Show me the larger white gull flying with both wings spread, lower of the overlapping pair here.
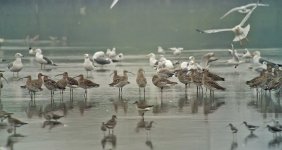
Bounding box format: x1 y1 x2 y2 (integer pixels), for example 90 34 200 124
196 5 257 45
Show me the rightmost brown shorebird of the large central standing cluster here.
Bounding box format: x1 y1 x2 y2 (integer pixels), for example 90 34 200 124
202 70 225 97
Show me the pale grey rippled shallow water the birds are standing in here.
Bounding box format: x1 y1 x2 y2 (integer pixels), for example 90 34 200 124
0 47 282 150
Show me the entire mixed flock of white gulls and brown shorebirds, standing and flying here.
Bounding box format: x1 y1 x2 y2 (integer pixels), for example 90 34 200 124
0 0 282 149
